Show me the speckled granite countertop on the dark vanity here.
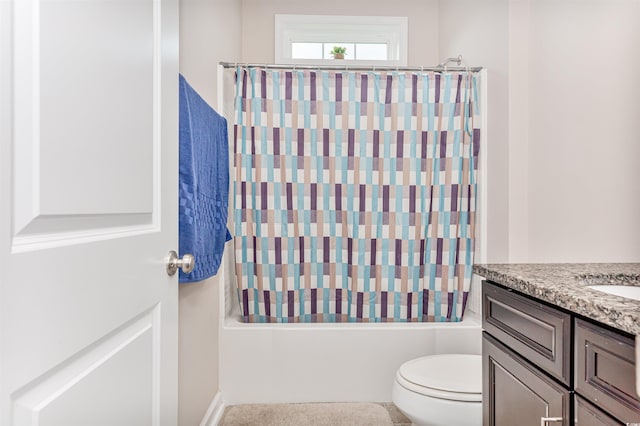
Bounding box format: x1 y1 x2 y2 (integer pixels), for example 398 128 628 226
473 263 640 335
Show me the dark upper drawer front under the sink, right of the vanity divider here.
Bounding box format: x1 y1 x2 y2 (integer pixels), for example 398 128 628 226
575 319 640 423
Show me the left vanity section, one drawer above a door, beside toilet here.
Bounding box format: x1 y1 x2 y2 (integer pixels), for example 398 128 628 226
482 282 571 426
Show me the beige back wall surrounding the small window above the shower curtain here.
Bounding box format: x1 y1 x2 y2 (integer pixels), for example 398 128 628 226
242 0 440 66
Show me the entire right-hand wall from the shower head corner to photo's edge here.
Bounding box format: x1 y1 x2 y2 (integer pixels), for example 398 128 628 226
439 0 640 262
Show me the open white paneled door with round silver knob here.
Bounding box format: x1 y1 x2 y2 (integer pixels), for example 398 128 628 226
0 0 178 426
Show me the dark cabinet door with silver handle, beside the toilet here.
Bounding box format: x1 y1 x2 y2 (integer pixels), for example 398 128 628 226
482 332 570 426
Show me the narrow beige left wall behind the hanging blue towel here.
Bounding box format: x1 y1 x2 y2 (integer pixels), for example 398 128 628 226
178 0 242 426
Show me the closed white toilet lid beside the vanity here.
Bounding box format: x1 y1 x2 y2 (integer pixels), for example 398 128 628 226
398 354 482 401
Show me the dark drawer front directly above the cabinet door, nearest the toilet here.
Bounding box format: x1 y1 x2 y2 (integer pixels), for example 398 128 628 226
482 281 571 386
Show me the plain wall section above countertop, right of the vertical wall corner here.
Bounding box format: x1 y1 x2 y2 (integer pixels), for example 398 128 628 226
518 0 640 262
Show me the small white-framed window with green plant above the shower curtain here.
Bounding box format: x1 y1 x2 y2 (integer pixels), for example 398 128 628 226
275 15 407 66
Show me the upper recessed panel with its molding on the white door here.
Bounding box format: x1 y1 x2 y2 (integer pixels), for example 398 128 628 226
11 0 162 253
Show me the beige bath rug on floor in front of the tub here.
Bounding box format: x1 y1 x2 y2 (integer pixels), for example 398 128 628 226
219 402 393 426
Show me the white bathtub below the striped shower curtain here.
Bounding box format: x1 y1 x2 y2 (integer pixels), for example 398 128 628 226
220 268 482 405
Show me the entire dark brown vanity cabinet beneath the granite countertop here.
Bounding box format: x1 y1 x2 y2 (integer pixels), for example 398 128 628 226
482 281 640 426
